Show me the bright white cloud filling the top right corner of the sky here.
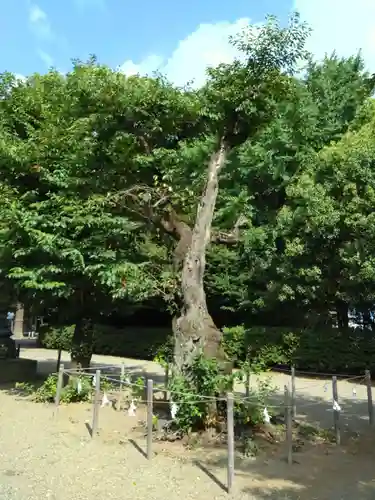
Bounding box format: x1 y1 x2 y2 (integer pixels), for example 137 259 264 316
294 0 375 71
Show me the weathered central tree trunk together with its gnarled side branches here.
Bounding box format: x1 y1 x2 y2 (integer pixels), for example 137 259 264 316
121 138 246 371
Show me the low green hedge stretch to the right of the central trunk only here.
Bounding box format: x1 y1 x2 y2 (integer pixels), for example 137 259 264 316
224 326 375 374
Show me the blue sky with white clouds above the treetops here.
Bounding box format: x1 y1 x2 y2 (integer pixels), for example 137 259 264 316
0 0 375 84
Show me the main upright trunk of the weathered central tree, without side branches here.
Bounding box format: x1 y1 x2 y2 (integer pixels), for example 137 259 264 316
173 140 228 371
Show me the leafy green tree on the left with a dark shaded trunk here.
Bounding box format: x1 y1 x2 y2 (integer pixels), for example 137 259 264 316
0 70 175 366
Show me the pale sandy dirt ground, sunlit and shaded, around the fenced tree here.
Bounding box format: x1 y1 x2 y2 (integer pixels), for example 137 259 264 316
0 349 375 500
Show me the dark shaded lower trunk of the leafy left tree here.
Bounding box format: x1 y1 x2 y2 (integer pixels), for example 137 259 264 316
70 317 94 369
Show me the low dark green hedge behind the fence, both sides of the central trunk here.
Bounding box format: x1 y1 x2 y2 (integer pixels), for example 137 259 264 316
40 325 375 374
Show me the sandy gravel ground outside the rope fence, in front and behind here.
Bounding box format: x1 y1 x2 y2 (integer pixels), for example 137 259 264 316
0 348 375 500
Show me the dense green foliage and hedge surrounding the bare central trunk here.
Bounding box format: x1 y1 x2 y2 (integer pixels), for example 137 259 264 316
0 13 375 371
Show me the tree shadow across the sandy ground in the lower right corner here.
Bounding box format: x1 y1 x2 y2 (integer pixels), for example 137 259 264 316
195 395 375 500
